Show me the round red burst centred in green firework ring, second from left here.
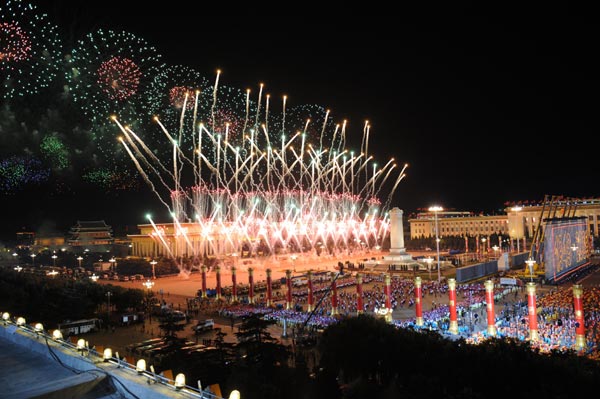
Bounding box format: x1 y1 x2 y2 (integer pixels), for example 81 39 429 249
98 57 142 101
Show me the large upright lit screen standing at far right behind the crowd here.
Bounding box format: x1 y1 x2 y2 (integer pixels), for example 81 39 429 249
544 218 587 280
